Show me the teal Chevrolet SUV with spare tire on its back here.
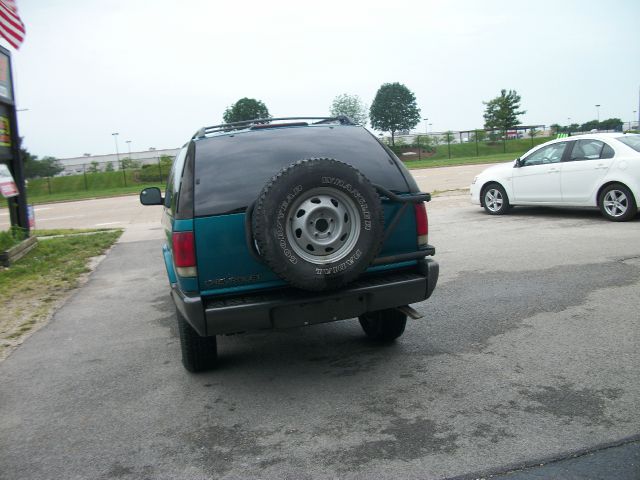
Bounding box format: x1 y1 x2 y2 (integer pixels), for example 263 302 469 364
140 117 438 372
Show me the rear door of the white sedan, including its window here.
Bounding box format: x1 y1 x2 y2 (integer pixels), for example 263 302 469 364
560 140 614 205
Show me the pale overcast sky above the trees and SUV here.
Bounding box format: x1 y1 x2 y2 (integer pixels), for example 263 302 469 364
5 0 640 158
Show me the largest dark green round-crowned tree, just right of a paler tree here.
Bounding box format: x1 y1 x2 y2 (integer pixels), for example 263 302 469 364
369 82 420 145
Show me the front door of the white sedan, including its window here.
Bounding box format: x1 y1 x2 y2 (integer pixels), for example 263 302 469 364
513 142 568 203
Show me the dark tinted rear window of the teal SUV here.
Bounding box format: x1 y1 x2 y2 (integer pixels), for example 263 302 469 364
194 125 409 216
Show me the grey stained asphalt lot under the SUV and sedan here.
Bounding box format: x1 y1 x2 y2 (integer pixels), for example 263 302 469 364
0 168 640 479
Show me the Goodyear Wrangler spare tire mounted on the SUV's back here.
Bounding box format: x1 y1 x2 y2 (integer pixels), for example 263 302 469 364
252 158 384 291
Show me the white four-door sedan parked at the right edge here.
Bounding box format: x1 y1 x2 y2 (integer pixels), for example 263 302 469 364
471 133 640 222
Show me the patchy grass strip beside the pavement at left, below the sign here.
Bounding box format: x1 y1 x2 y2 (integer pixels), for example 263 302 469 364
0 230 122 360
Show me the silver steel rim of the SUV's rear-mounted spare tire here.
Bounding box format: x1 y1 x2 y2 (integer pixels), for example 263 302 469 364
287 187 361 265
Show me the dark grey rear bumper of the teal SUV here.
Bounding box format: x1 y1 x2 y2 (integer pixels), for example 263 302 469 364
171 259 439 336
